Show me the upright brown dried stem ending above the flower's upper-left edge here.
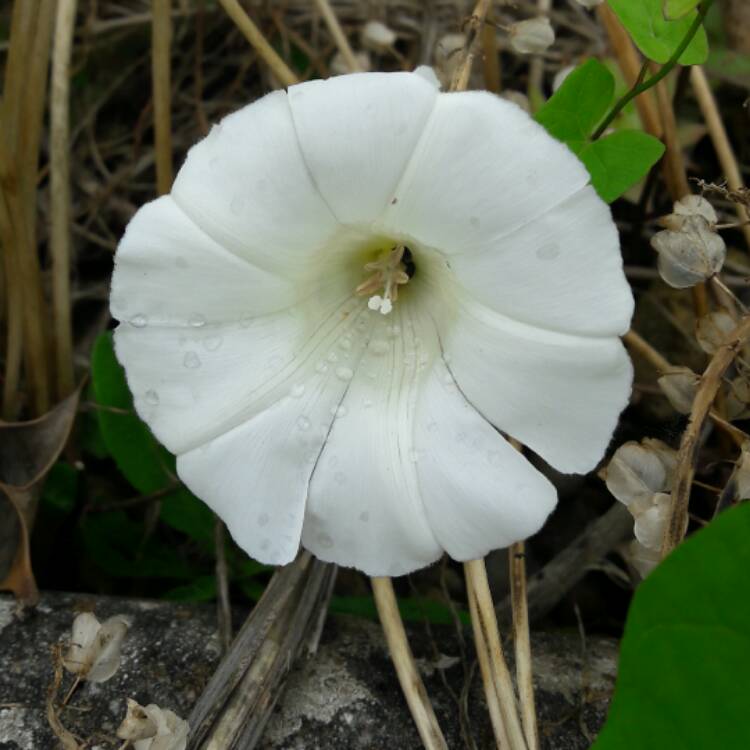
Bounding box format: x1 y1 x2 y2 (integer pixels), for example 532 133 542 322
151 0 172 195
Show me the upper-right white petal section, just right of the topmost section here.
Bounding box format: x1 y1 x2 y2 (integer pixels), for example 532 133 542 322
383 91 589 255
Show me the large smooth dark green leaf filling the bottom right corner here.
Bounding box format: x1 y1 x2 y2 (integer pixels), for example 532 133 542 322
594 504 750 750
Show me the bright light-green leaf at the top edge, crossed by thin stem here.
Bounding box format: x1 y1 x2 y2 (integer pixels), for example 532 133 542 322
609 0 708 65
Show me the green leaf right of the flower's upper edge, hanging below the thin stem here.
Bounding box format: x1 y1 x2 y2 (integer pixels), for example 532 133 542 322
578 130 664 203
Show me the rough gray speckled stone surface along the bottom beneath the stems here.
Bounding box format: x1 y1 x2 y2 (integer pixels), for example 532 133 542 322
0 594 616 750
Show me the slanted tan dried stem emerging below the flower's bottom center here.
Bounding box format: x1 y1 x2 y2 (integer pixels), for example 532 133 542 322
371 577 448 750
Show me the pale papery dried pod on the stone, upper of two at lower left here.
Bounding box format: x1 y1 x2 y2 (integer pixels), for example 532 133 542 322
63 612 130 682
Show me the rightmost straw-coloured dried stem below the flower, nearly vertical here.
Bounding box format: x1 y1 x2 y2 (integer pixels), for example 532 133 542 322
508 542 539 750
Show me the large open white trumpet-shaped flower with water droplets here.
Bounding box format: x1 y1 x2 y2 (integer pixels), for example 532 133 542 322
111 73 633 575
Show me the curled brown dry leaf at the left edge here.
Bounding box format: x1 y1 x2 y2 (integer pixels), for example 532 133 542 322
0 387 81 605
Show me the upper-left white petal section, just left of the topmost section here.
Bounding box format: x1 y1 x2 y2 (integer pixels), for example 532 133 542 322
172 91 337 276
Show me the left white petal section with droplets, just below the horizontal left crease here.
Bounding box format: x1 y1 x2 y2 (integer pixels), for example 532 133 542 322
115 301 366 453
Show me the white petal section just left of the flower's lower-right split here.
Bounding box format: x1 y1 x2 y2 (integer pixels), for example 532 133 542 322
415 362 557 560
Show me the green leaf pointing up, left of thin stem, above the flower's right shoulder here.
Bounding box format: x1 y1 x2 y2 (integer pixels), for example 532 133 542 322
536 59 615 148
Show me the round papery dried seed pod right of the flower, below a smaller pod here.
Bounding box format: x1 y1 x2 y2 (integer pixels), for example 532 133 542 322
651 215 727 289
